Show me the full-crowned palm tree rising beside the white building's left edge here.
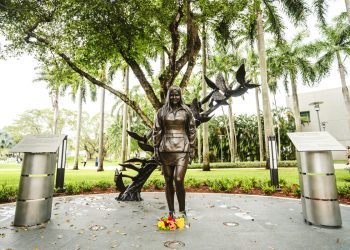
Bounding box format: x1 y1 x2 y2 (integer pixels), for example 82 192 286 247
267 32 315 132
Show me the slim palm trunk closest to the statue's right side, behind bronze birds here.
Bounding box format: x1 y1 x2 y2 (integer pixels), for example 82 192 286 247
202 23 210 171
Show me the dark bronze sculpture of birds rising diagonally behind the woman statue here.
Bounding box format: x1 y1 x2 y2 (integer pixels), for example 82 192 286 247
114 64 259 201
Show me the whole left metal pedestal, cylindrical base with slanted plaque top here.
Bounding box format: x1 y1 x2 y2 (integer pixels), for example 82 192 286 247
11 135 67 226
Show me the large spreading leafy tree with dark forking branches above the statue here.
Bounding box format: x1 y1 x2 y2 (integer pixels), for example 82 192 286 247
0 0 246 131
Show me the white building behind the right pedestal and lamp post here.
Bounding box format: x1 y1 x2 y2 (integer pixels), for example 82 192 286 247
287 88 350 160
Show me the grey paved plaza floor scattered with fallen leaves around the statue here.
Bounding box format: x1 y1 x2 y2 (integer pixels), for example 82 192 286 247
0 193 350 250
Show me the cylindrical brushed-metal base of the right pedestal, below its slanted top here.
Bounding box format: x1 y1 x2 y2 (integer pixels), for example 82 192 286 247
298 151 342 227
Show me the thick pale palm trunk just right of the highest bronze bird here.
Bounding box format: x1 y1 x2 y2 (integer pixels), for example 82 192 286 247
257 10 274 157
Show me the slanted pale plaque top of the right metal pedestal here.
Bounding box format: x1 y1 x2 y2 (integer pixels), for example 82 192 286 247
287 132 346 152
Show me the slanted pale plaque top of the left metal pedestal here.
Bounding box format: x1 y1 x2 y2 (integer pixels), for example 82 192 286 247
10 135 66 153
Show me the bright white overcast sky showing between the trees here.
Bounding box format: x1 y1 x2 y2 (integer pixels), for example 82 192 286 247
0 0 349 129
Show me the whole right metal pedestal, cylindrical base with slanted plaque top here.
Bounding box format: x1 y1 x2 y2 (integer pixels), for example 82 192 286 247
288 132 345 227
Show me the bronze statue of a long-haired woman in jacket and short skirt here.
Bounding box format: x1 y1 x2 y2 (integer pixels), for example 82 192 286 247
153 86 196 217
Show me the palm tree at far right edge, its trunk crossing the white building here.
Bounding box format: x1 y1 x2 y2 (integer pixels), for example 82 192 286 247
310 15 350 131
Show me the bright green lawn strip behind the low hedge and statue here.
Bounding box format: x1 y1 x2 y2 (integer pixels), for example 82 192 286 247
0 164 350 187
